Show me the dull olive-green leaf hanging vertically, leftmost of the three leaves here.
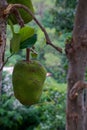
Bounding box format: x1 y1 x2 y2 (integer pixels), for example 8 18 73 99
10 33 21 53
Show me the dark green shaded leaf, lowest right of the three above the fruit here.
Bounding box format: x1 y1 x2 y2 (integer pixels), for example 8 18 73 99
20 34 37 49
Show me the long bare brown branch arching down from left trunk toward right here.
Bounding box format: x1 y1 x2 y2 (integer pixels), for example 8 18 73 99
4 4 62 53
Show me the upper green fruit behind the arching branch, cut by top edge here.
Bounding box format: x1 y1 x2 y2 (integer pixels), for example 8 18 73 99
7 0 34 24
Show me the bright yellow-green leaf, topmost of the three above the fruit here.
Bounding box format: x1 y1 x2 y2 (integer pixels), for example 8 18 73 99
19 26 35 42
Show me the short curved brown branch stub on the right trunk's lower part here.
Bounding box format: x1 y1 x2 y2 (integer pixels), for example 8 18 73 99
69 81 87 100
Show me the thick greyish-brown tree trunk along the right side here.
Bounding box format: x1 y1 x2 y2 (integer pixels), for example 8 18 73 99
65 0 87 130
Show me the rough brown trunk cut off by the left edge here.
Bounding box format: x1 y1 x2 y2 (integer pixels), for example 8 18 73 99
0 0 7 94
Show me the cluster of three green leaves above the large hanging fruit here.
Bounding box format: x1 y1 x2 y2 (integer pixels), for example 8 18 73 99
10 26 37 53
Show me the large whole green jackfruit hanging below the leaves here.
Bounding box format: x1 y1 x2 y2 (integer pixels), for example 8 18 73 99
12 61 46 105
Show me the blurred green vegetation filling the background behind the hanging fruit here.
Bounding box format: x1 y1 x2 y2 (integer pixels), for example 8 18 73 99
0 0 77 130
